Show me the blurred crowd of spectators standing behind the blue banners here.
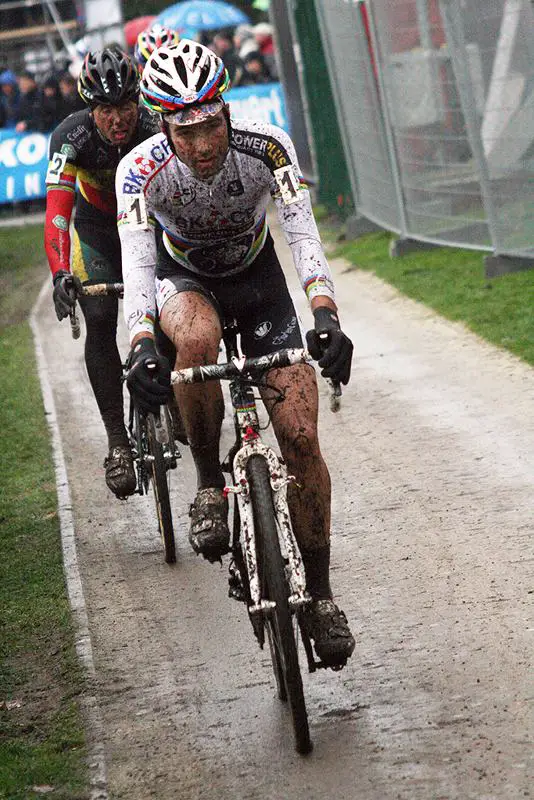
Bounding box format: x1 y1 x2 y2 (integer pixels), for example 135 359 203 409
0 22 278 133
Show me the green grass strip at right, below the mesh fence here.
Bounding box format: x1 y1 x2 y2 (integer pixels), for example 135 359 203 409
321 226 534 365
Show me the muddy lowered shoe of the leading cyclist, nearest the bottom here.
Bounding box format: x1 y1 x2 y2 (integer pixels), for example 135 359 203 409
302 600 356 669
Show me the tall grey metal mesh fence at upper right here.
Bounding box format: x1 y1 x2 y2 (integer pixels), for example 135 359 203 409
315 0 534 259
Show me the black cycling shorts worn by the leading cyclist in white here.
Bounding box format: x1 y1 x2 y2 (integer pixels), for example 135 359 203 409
156 234 303 358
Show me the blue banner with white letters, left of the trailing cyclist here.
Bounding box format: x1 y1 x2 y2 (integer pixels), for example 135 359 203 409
0 128 50 203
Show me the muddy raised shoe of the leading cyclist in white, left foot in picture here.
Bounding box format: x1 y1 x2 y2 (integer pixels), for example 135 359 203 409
189 489 230 563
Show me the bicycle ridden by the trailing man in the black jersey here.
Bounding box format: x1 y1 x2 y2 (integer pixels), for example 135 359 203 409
70 281 181 564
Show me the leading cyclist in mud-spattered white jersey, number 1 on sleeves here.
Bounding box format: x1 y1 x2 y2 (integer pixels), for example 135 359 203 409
116 39 355 666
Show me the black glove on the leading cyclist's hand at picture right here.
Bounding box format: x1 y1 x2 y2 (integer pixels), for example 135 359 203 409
306 306 354 384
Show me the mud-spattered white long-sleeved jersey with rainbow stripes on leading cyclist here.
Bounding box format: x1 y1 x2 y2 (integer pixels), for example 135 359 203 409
116 119 334 340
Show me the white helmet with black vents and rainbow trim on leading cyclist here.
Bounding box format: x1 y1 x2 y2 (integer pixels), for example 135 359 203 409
141 39 230 114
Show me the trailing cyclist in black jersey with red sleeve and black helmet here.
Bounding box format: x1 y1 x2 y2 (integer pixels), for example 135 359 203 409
45 48 156 498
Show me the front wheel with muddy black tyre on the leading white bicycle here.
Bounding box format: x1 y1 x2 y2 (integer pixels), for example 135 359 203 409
247 455 313 754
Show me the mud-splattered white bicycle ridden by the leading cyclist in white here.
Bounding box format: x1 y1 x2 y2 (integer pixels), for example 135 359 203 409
171 324 340 754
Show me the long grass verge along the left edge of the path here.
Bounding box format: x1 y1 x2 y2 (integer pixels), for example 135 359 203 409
0 225 87 800
